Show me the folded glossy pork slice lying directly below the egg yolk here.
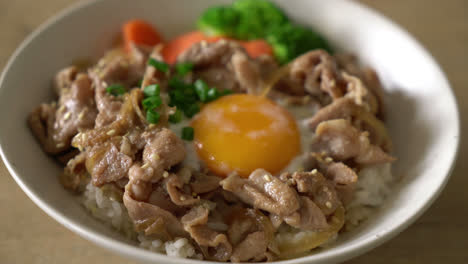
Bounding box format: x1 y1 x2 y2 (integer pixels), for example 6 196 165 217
220 169 299 216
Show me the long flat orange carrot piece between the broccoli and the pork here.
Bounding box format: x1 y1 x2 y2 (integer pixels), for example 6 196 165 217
162 31 273 64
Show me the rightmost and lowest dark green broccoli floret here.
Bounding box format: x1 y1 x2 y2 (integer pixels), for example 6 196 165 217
266 24 332 64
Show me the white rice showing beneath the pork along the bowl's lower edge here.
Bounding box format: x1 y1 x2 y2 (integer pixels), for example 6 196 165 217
83 163 394 259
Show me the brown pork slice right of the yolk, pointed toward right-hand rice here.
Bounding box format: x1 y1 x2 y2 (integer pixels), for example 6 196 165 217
311 119 395 165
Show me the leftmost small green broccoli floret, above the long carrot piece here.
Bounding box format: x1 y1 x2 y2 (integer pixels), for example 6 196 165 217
197 6 239 37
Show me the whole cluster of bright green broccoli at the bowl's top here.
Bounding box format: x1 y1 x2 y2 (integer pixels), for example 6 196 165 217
197 0 331 64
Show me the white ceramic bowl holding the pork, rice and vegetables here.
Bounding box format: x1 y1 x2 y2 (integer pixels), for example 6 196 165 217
0 0 459 264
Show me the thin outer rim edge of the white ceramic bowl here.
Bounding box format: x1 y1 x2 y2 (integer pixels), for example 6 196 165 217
0 0 461 264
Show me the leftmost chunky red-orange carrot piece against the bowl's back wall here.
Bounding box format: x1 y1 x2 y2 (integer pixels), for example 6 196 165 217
122 19 163 51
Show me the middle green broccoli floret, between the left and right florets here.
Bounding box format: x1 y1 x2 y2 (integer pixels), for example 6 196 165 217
232 0 289 40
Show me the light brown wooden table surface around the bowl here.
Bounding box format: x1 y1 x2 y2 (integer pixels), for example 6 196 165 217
0 0 468 264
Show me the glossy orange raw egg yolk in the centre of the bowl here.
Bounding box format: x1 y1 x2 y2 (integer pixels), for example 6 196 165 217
192 94 300 177
